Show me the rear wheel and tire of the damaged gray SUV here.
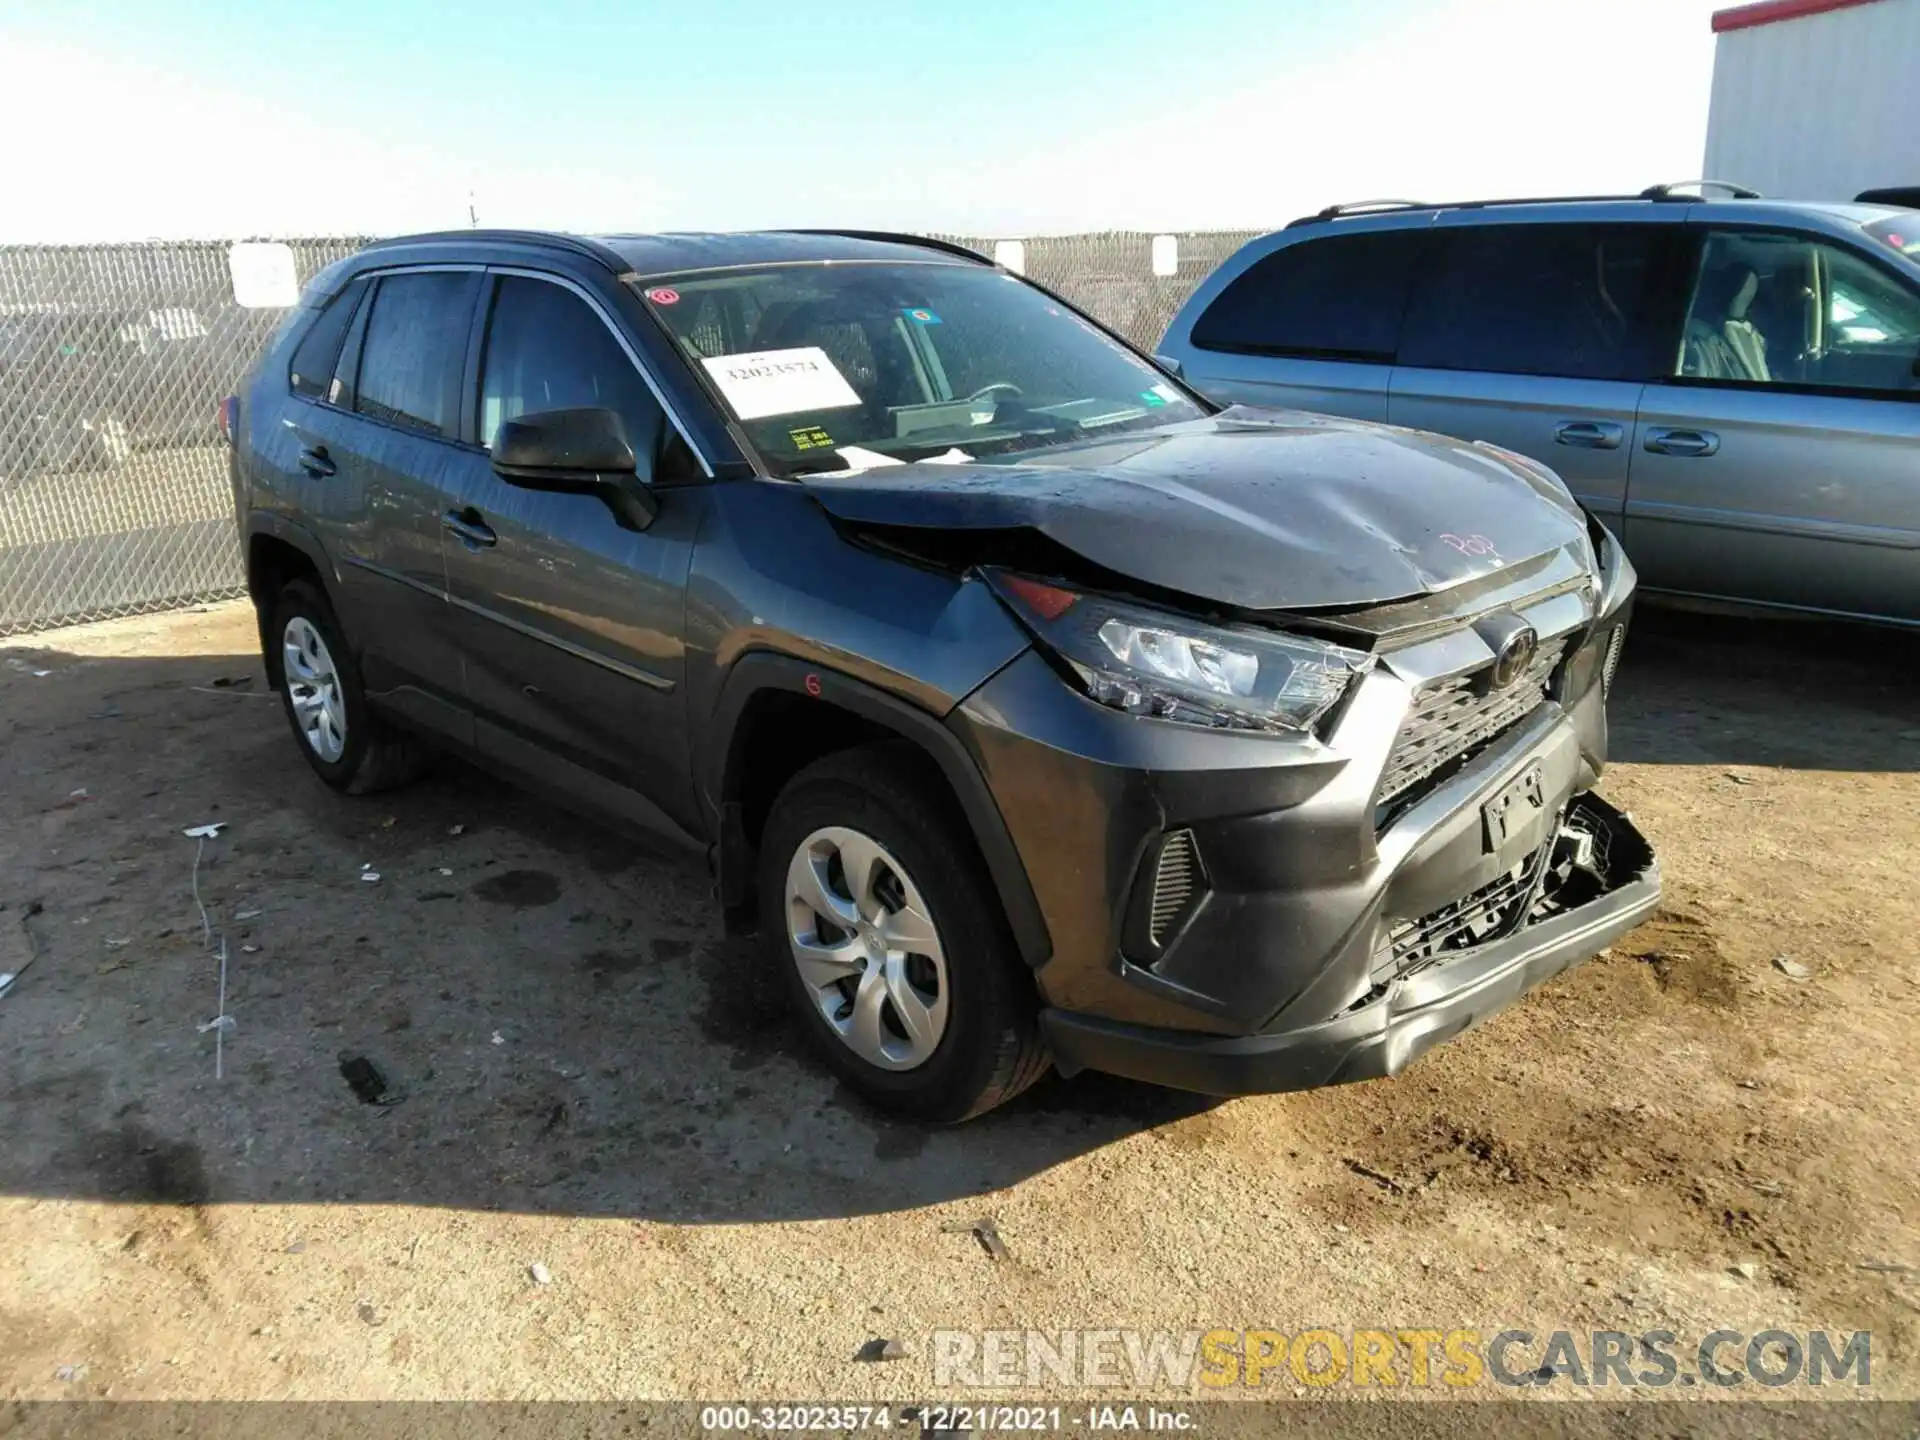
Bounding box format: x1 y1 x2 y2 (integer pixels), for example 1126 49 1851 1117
269 580 430 795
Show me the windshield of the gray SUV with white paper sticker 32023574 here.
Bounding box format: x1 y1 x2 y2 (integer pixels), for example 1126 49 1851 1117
641 261 1204 474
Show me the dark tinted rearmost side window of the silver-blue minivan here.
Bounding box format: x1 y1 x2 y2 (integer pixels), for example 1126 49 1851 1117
1192 230 1427 363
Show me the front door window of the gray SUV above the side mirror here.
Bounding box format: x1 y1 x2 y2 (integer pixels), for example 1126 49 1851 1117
480 275 664 455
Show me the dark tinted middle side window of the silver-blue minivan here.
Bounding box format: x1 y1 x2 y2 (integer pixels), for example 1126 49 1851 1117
1400 225 1678 380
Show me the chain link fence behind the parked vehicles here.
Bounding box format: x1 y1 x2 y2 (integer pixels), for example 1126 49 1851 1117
0 230 1256 636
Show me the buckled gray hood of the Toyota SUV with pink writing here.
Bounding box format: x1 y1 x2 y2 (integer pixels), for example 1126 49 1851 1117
803 405 1592 611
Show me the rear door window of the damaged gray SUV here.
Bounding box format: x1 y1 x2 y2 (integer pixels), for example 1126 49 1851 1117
353 271 478 438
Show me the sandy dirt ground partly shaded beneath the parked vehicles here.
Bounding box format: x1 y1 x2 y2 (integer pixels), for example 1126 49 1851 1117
0 605 1920 1400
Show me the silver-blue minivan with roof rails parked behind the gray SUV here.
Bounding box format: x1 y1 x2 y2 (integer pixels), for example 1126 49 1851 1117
1160 186 1920 624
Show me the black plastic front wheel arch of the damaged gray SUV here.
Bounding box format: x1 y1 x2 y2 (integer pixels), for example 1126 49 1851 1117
699 653 1052 968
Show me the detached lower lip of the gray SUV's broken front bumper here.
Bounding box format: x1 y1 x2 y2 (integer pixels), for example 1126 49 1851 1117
1043 797 1661 1094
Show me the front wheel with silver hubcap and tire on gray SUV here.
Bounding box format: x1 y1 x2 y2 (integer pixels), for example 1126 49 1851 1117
758 745 1050 1121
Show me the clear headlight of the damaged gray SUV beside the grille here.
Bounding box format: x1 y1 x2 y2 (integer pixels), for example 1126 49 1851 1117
989 570 1373 733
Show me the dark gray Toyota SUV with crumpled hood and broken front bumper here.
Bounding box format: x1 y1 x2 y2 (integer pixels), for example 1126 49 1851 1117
225 230 1659 1119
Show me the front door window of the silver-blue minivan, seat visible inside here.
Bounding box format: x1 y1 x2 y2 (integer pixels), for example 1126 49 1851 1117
1676 230 1920 394
